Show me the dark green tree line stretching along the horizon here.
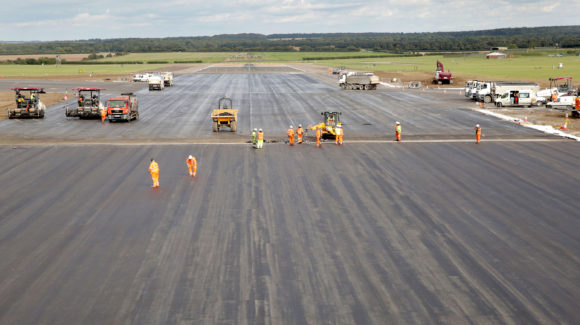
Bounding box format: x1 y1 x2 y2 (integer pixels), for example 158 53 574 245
0 25 580 55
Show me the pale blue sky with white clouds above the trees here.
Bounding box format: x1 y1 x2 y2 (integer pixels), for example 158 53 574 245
0 0 580 41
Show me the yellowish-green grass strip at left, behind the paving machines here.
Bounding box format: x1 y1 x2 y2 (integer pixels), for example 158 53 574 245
0 64 166 77
